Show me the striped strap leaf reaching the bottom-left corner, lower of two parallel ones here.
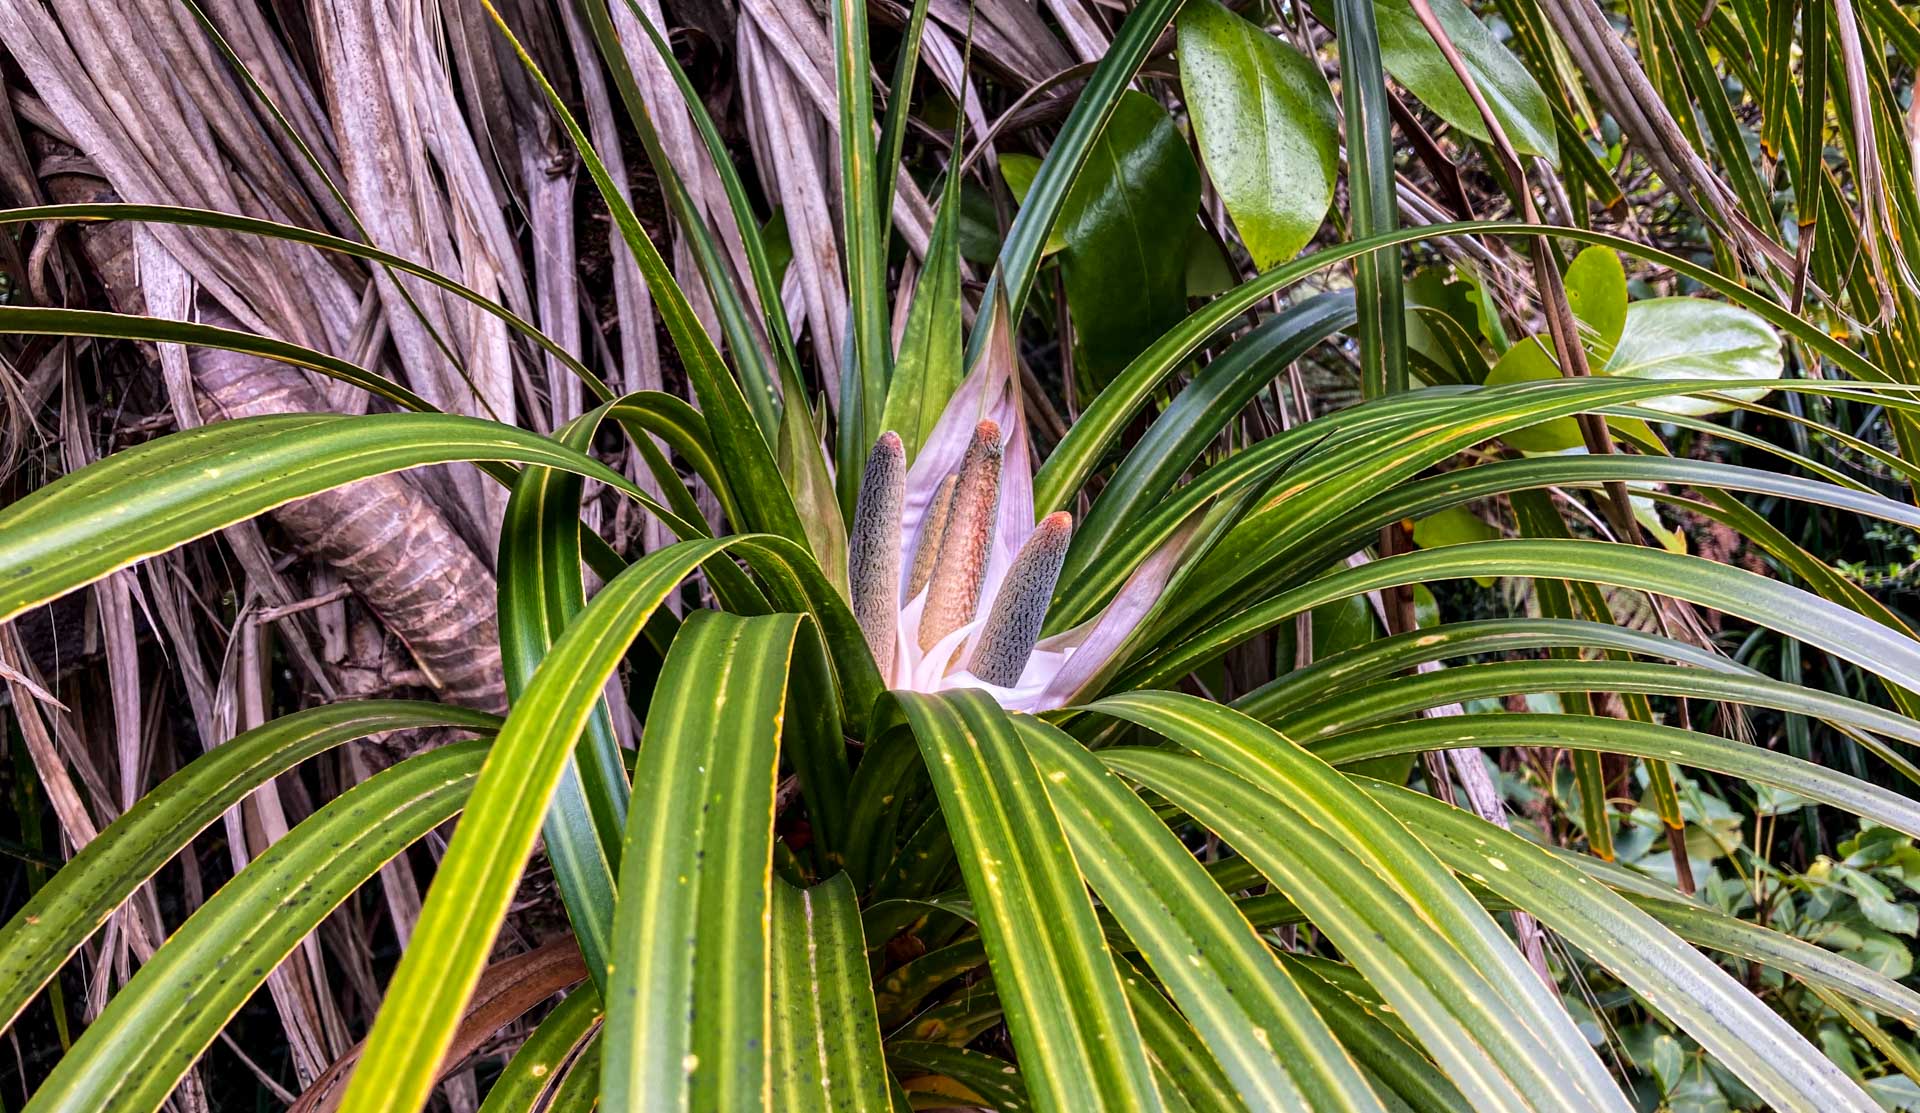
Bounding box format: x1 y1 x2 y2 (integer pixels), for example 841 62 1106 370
27 741 488 1113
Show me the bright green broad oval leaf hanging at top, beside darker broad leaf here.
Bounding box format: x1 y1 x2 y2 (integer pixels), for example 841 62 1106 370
1179 0 1340 271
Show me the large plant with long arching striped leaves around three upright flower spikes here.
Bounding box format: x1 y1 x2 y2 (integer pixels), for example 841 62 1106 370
11 0 1920 1113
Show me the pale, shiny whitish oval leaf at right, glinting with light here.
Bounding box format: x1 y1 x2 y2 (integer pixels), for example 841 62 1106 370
1601 297 1784 414
